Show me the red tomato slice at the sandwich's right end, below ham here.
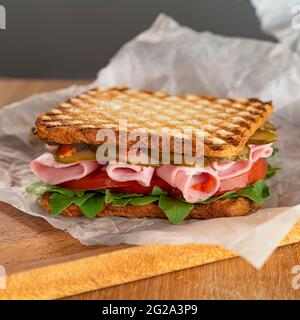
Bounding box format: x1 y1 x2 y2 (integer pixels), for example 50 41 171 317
215 158 268 195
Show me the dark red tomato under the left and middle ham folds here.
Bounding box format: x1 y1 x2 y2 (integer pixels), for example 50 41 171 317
59 168 172 194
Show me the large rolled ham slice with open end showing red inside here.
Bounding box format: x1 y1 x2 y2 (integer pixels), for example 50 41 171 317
156 164 220 203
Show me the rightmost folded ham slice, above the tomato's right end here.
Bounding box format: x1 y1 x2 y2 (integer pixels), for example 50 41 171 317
211 143 273 180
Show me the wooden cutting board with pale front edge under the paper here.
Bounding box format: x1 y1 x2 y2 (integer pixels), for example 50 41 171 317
0 203 300 299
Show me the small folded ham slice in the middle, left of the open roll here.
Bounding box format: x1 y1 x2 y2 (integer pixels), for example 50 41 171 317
106 163 155 187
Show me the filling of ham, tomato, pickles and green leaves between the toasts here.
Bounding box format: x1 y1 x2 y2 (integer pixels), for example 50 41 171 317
27 124 277 223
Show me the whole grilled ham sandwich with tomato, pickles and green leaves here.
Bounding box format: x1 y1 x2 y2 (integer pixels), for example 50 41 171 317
26 87 277 224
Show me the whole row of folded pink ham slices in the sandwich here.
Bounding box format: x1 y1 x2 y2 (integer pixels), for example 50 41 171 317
31 144 273 203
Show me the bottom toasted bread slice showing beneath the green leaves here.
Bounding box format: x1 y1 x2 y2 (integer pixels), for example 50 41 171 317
41 192 260 219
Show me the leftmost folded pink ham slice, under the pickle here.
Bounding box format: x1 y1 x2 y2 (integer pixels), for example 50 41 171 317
30 152 99 185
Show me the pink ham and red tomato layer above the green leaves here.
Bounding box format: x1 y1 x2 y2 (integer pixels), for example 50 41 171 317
31 144 273 203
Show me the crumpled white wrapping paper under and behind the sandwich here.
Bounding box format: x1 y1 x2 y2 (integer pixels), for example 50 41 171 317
0 15 300 268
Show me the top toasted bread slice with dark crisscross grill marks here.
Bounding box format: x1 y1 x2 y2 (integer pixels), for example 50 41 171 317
34 87 273 158
